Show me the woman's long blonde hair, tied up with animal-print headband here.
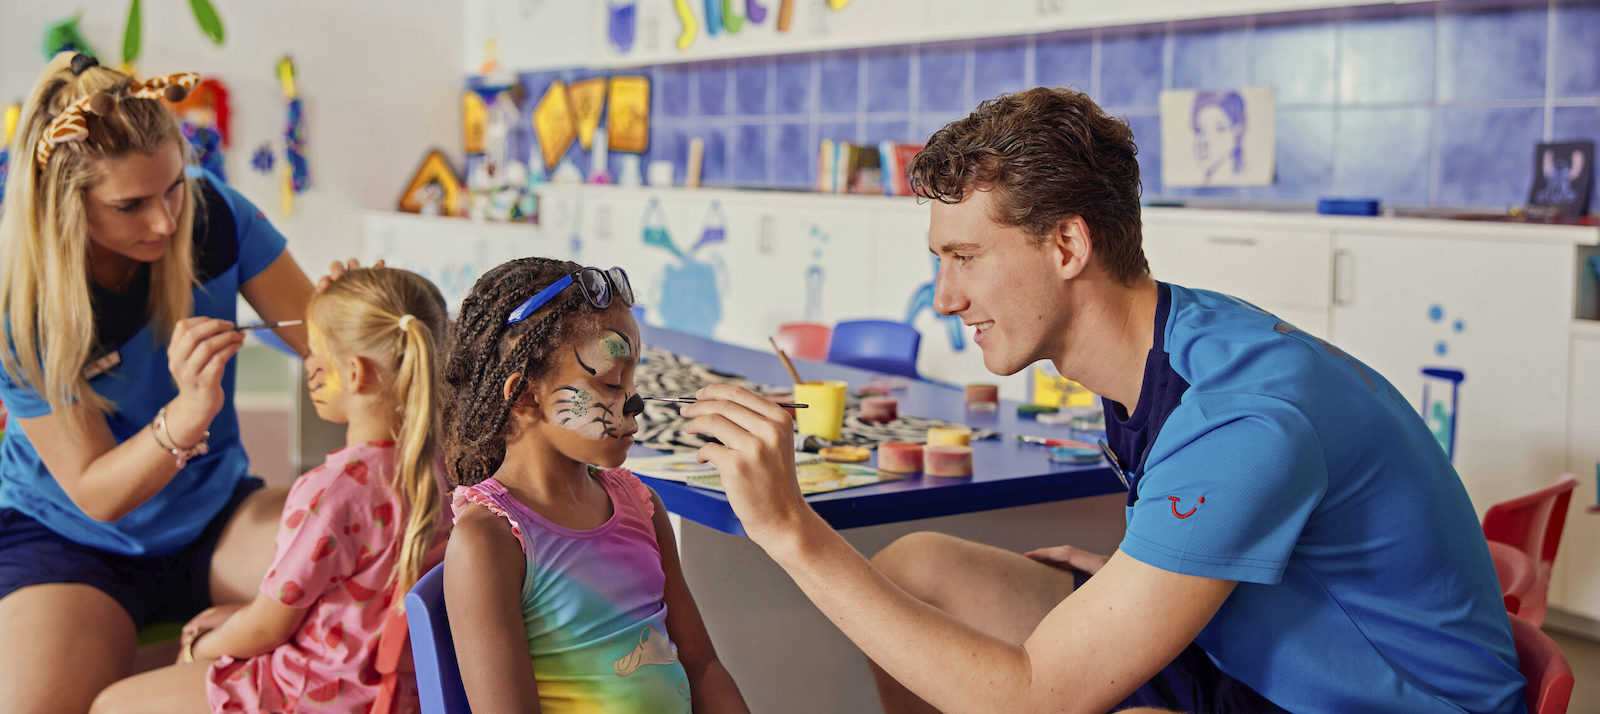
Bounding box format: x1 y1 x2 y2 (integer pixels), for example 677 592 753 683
0 53 197 411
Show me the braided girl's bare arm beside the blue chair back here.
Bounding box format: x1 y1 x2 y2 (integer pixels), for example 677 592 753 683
445 506 539 712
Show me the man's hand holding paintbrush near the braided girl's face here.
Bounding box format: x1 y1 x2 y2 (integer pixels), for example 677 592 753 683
680 384 811 548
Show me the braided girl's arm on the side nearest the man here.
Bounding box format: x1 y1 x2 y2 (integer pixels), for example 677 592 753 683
650 491 750 712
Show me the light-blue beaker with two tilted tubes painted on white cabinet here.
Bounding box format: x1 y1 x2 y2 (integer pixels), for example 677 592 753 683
642 199 728 338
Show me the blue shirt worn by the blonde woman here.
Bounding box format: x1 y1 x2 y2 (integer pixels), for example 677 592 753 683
0 168 285 556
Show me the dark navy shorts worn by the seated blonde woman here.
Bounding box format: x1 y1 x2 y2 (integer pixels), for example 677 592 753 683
0 475 264 628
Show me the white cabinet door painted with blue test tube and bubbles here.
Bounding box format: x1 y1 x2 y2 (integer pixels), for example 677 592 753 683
1330 232 1573 514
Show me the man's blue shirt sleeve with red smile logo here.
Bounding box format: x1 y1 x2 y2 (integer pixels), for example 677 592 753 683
1120 397 1328 584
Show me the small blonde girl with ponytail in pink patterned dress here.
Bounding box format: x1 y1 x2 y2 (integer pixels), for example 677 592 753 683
94 267 448 712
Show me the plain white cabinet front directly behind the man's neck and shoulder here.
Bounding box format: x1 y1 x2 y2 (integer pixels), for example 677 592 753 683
1144 221 1333 336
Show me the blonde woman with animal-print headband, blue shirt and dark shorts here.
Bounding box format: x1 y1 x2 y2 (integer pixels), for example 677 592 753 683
0 53 321 712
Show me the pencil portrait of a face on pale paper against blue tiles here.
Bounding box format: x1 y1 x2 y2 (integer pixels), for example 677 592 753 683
1160 86 1277 186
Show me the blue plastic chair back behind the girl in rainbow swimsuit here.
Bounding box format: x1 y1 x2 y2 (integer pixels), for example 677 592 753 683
405 564 472 714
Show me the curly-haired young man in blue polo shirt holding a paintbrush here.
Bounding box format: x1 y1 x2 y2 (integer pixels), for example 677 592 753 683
685 88 1525 712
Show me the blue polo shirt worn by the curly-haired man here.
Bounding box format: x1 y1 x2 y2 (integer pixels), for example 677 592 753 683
1106 283 1526 712
